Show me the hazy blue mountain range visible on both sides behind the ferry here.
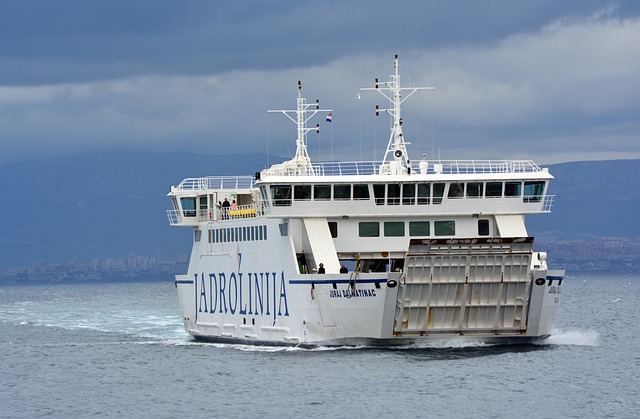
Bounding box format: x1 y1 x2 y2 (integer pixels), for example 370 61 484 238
0 150 640 268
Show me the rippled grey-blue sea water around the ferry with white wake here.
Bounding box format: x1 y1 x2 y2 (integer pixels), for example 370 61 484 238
0 272 640 418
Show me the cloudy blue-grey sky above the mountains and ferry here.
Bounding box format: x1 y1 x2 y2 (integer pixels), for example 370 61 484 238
0 0 640 164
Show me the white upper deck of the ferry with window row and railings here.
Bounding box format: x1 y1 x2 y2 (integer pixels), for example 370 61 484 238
169 160 553 225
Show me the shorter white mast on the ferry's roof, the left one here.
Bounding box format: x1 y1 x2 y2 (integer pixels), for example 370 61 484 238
267 81 333 175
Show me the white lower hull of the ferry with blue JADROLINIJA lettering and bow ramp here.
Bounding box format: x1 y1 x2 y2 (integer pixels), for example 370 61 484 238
176 220 562 346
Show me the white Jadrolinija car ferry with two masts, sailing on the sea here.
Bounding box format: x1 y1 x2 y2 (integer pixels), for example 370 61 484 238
167 56 564 347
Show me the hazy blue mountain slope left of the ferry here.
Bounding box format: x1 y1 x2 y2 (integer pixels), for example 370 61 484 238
0 150 281 268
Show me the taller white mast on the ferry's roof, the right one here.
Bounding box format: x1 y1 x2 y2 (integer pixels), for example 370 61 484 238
360 54 433 175
